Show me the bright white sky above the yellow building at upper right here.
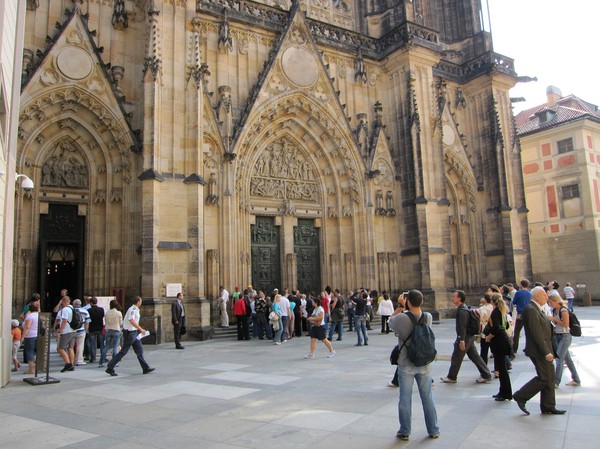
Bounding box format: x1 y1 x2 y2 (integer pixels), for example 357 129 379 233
482 0 600 113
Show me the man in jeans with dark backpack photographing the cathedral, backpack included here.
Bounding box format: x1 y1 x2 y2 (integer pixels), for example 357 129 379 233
388 290 440 441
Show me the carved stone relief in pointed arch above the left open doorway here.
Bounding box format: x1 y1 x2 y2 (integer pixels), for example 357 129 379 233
42 139 89 189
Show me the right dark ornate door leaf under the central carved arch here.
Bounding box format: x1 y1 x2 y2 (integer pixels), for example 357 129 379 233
294 219 321 293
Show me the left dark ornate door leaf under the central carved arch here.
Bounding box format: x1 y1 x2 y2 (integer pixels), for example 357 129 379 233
250 217 281 295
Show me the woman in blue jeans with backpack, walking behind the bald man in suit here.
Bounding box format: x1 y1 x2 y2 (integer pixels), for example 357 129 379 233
548 295 581 388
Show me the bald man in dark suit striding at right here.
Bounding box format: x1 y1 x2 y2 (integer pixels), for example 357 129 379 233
513 287 566 415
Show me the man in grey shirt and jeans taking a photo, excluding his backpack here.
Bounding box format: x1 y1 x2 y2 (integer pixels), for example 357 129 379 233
388 290 440 441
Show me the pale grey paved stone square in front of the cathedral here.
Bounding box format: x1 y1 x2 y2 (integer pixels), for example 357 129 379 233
0 307 600 449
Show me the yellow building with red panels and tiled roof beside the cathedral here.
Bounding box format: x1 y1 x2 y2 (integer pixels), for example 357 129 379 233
515 86 600 298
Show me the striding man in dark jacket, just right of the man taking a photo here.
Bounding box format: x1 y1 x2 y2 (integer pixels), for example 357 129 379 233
441 290 492 384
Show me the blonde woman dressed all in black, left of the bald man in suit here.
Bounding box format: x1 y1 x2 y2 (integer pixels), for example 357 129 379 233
485 293 512 401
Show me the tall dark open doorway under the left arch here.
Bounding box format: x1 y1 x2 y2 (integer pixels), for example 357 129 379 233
39 204 85 312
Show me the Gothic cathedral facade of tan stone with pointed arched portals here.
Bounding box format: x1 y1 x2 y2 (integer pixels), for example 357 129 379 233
14 0 531 338
